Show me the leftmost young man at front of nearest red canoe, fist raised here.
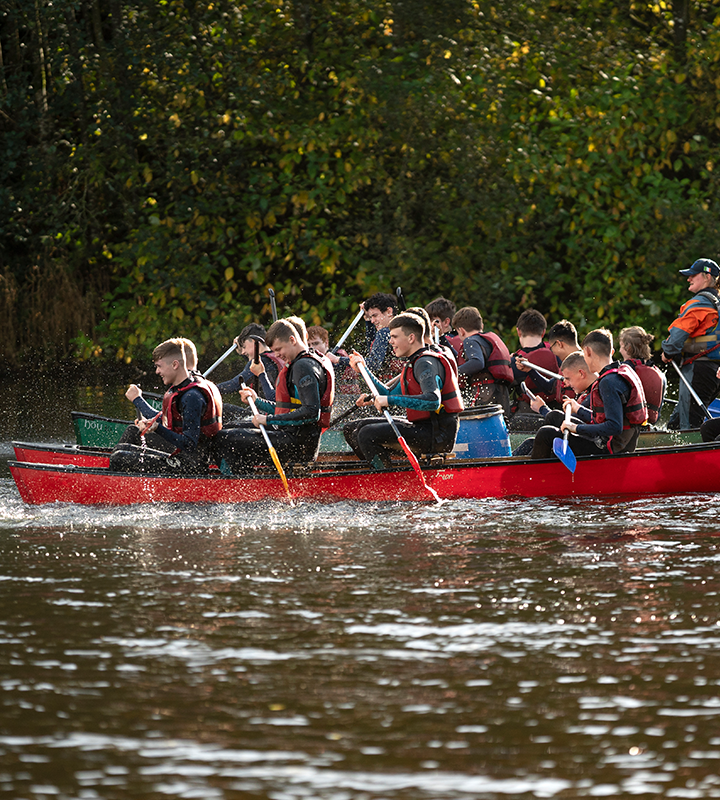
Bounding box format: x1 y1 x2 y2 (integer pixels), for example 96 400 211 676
110 339 222 474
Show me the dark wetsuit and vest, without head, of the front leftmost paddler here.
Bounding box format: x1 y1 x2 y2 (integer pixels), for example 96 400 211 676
110 376 222 475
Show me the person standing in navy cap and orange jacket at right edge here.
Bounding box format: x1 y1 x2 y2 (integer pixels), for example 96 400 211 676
662 258 720 430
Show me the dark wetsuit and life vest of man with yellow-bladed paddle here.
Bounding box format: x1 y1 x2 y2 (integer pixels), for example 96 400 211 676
214 351 334 473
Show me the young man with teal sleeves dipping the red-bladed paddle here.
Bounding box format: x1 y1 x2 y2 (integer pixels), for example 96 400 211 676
343 313 463 467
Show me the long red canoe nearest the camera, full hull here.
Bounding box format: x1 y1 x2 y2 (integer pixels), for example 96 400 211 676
9 443 720 505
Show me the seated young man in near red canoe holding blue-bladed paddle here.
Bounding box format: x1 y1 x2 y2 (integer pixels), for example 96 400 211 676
532 329 647 458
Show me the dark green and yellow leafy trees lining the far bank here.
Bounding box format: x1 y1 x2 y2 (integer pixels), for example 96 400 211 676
0 0 720 370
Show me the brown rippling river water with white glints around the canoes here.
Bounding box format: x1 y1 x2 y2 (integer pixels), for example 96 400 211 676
0 378 720 800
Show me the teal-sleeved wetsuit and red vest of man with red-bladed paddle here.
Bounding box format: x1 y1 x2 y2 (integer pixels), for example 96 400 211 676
343 349 462 467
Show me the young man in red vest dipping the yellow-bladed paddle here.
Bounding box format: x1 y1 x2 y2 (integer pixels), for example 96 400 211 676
215 319 335 473
